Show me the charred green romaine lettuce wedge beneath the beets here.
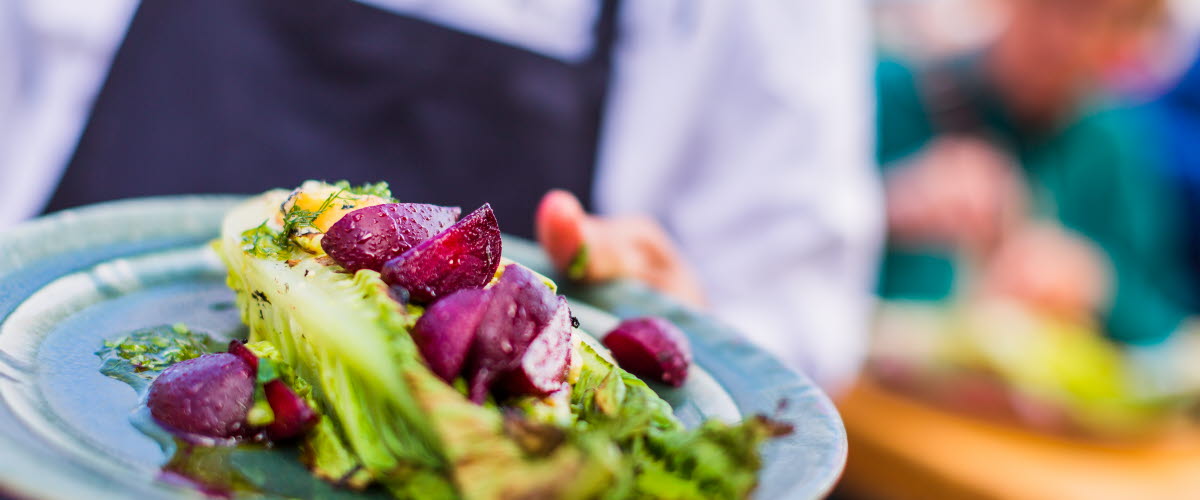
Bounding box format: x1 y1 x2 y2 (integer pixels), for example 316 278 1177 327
216 191 779 499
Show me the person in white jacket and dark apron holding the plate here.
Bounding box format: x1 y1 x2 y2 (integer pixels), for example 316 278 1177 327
0 0 878 388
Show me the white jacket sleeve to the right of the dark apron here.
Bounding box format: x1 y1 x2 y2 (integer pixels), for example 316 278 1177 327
595 0 882 391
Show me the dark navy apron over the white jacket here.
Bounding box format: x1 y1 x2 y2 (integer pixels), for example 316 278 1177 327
47 0 617 236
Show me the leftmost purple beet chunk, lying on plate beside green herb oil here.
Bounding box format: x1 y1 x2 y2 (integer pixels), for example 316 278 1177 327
146 353 254 439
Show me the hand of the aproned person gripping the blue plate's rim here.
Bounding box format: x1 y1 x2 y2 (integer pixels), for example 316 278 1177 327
535 191 704 307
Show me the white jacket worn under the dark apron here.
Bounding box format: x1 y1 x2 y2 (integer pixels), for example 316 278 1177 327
0 0 882 390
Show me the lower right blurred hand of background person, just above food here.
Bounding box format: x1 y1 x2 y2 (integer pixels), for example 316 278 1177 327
980 224 1112 319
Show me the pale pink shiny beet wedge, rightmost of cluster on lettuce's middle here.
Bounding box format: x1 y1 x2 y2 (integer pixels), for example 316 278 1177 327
505 297 571 396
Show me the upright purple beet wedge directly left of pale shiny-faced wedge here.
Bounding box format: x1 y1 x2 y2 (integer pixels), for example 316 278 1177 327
468 264 561 403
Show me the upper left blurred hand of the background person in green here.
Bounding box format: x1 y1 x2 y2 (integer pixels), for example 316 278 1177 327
886 138 1026 253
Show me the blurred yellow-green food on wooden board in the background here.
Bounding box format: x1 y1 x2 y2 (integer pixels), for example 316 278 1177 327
871 302 1195 440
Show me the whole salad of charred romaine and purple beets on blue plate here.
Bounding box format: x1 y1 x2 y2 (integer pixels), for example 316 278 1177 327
98 181 792 499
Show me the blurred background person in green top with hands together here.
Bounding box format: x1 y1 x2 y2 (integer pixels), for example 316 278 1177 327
877 0 1190 343
